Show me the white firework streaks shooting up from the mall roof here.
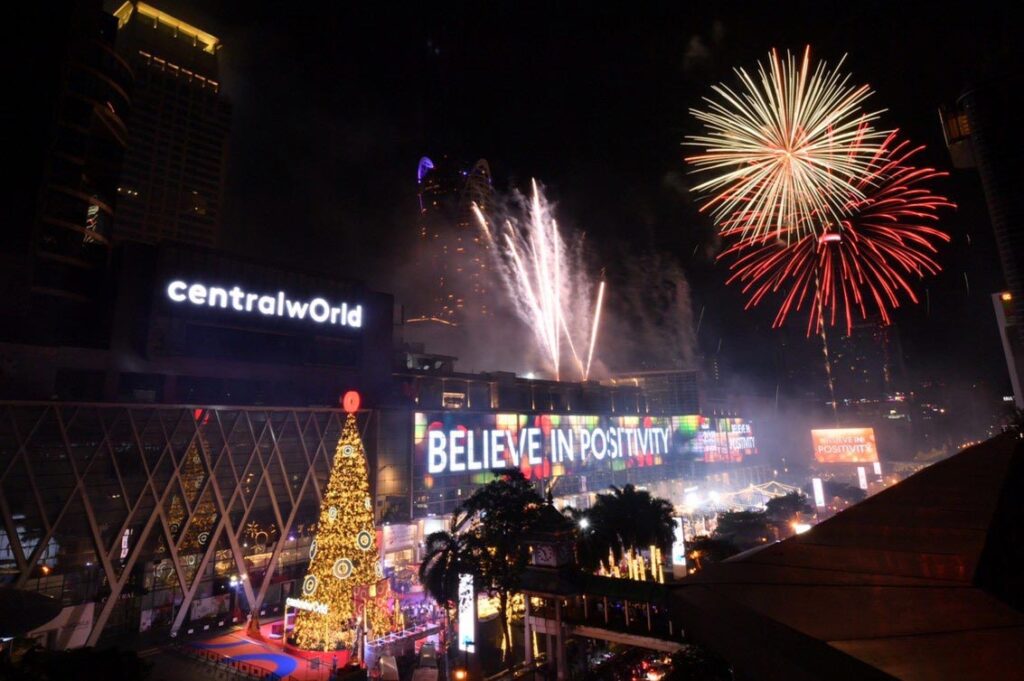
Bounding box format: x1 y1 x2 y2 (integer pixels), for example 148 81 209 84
473 181 604 380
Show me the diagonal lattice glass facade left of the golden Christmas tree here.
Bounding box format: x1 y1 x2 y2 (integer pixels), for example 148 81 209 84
0 402 371 645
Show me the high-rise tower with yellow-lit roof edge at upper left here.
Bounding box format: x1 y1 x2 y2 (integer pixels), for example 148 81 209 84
114 2 230 246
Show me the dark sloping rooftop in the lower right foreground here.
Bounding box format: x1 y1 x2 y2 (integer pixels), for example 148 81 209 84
672 434 1024 681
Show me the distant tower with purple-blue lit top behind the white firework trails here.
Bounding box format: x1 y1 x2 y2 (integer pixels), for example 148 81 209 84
414 157 495 325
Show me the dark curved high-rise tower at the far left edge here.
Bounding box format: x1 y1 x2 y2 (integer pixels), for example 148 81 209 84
0 0 132 344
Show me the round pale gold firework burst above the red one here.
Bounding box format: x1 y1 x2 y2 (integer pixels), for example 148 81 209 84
684 47 888 243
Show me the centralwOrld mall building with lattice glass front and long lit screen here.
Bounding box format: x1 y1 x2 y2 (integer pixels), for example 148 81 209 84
0 243 767 648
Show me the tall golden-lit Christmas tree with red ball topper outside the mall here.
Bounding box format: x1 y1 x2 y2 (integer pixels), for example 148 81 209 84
294 395 392 650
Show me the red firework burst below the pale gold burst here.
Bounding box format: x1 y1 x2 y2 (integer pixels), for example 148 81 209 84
719 134 955 335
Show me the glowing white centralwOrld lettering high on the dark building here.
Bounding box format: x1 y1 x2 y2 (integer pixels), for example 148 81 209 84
166 280 362 329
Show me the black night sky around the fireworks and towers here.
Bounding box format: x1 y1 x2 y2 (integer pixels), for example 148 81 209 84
148 1 1021 390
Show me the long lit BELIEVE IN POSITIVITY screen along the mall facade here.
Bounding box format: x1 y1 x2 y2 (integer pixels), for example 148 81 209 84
412 410 757 517
